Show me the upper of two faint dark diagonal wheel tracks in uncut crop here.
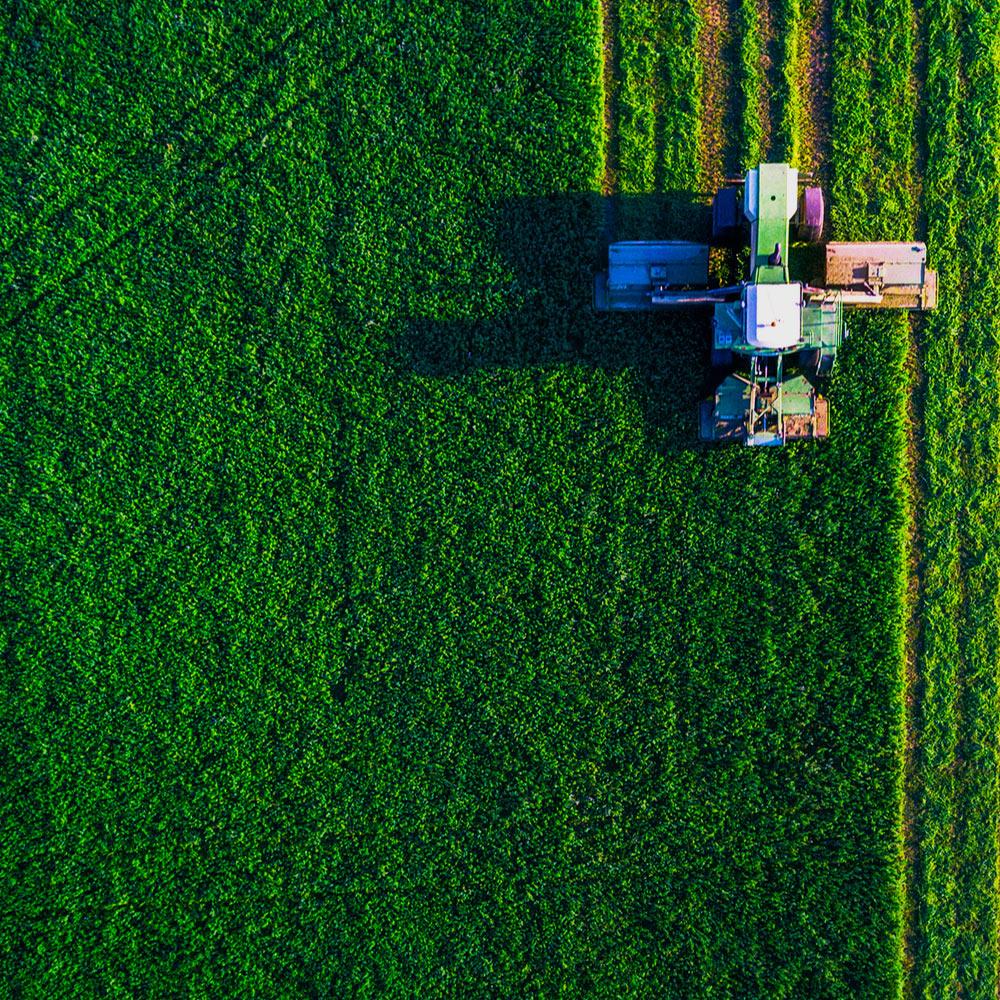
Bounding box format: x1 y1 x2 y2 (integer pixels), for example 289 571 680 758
0 15 330 257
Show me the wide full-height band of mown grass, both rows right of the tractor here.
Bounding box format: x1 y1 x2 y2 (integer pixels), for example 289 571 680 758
914 2 1000 997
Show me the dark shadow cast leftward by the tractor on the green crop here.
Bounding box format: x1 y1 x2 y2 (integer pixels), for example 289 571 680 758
392 191 717 451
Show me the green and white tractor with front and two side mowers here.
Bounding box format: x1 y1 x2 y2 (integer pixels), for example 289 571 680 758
594 163 937 445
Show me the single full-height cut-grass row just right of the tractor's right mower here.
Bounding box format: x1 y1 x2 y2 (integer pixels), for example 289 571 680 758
912 2 964 998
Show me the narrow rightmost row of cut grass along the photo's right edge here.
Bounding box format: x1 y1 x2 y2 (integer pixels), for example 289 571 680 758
955 4 1000 997
